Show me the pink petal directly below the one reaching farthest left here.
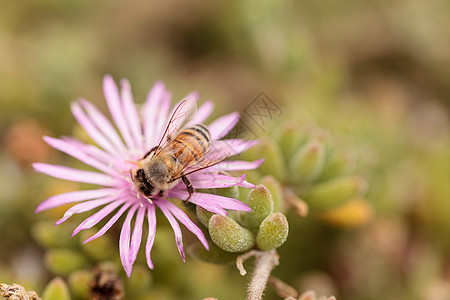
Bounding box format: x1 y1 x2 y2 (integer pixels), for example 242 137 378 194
35 188 119 213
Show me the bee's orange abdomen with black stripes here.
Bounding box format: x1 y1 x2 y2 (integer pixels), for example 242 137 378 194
168 124 211 165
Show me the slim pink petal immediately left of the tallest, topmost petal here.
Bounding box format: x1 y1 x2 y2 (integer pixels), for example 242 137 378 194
80 99 126 152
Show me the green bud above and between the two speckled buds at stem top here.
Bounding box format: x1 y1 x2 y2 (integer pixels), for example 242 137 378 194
240 184 273 230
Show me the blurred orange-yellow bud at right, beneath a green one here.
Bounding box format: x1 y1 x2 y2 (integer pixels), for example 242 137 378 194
319 198 373 227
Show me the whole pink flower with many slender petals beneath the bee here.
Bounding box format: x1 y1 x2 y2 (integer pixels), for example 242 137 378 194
33 76 262 276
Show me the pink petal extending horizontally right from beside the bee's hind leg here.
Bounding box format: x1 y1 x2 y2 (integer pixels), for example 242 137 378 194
189 173 245 189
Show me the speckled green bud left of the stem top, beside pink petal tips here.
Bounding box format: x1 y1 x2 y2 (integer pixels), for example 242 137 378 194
208 214 254 252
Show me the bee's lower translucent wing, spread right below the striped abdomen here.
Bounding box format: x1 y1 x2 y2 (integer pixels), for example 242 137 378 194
173 141 231 180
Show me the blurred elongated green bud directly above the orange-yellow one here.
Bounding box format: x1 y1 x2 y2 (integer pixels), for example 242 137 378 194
303 176 367 209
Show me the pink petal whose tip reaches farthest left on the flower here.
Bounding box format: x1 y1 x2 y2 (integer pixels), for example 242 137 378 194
33 163 117 186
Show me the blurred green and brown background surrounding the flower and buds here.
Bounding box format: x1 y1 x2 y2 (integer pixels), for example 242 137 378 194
0 0 450 300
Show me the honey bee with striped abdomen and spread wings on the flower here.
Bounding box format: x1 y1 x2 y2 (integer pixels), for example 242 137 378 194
130 99 229 201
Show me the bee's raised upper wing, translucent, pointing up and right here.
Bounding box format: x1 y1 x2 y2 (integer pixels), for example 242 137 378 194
153 97 196 155
